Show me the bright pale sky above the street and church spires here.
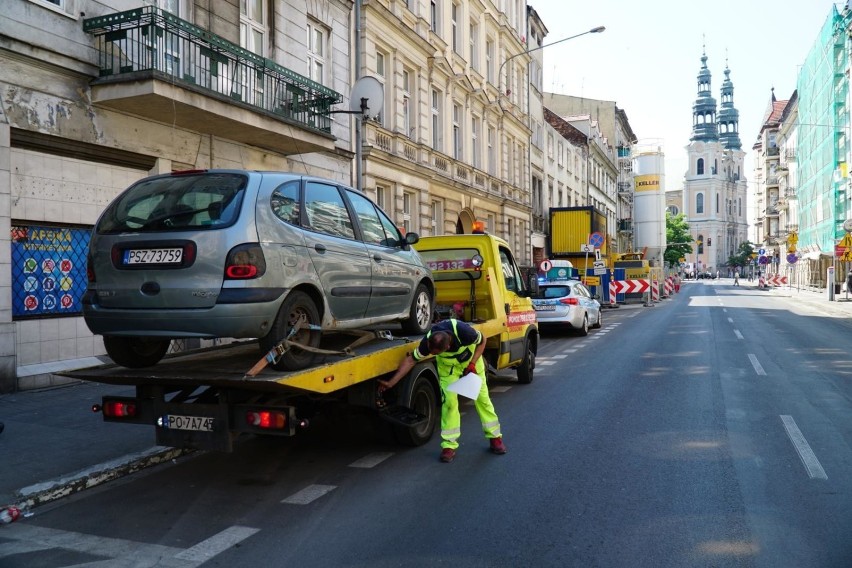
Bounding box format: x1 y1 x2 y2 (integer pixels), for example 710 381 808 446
528 0 843 189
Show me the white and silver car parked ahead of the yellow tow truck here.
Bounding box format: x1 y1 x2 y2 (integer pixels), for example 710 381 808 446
532 280 603 335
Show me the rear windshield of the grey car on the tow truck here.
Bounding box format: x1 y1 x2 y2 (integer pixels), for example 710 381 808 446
97 173 248 234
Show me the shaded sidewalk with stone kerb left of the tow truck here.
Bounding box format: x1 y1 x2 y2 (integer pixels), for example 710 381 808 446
0 382 185 512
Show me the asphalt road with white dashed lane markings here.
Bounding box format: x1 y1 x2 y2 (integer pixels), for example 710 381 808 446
0 280 852 568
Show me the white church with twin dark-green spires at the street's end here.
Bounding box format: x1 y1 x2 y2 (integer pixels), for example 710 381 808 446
682 51 748 276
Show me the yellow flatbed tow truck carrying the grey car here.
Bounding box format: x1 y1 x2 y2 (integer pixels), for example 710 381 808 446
62 230 539 452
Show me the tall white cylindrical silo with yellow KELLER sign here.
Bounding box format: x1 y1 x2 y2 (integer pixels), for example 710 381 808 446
632 139 666 266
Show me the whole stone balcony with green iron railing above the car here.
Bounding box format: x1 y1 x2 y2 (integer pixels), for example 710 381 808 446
83 6 343 154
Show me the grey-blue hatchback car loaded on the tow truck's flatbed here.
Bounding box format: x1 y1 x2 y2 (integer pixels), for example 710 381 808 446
83 170 435 370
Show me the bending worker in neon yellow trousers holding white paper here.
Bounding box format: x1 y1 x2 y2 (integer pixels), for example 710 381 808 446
379 318 506 463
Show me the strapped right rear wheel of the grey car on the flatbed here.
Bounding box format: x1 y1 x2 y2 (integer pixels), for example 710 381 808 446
260 291 322 371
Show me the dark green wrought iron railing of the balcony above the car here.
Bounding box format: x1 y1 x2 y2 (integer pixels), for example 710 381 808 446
83 6 343 134
